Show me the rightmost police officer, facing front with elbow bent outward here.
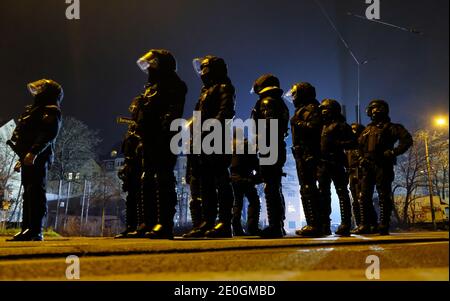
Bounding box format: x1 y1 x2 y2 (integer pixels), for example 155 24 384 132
355 99 413 235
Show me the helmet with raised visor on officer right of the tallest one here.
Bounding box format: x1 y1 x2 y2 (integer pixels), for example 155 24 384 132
192 55 228 86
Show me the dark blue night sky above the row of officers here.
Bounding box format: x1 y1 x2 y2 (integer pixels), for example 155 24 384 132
0 0 449 151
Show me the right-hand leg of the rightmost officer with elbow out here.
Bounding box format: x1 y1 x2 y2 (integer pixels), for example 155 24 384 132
376 166 394 235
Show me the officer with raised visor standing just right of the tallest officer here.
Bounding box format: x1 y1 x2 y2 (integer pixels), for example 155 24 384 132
194 55 235 238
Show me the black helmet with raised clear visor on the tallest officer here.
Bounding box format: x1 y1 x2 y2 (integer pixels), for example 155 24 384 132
137 49 177 74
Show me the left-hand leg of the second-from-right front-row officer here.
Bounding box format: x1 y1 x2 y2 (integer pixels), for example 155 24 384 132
317 164 331 235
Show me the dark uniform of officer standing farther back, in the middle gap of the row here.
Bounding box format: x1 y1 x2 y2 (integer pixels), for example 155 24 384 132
231 140 261 236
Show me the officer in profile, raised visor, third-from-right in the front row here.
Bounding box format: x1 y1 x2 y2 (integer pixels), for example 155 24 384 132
285 82 322 237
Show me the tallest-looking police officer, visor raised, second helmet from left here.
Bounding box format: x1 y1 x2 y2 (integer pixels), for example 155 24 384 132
137 49 187 239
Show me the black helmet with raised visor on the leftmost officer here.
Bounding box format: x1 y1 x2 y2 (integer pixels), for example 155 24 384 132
27 78 64 106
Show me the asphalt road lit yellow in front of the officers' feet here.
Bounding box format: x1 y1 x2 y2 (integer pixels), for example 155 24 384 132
0 232 449 281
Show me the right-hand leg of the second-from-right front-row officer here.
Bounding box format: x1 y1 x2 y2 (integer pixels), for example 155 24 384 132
332 165 352 236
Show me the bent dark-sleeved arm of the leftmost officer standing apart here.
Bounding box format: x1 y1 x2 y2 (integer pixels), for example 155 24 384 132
30 107 61 156
